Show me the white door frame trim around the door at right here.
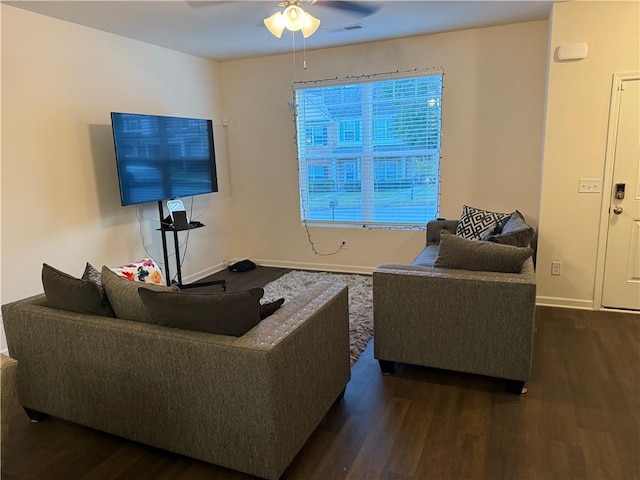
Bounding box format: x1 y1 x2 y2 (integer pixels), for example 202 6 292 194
593 72 640 312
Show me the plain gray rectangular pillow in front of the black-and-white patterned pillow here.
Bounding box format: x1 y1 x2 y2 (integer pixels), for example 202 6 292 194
434 232 533 273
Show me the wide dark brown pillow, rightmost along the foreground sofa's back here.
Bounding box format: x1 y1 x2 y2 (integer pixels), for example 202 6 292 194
138 287 264 337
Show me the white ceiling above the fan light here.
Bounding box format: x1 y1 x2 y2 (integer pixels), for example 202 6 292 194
3 0 554 61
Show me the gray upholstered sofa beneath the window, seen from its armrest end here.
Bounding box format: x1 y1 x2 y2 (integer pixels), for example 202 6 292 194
373 219 536 393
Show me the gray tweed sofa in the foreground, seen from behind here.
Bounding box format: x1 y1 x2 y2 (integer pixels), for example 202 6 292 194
2 282 351 479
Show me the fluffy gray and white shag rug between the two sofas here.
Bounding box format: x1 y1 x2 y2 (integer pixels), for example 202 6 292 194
263 270 373 365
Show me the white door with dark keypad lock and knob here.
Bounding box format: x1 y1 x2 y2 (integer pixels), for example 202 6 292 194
602 78 640 310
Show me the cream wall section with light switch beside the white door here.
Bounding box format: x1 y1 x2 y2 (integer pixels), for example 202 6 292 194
537 2 640 308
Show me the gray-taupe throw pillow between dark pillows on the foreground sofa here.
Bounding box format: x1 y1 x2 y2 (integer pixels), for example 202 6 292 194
100 266 180 323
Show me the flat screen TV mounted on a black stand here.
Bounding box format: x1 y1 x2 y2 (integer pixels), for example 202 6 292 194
111 112 218 205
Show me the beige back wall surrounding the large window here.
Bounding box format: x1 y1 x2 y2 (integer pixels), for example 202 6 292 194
221 21 547 272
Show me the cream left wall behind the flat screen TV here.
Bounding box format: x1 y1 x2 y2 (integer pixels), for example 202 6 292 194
0 4 231 312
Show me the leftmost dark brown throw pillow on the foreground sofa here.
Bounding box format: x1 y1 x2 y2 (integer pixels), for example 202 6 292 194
42 263 114 317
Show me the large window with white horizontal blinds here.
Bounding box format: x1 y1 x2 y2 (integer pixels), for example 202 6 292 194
294 71 442 227
